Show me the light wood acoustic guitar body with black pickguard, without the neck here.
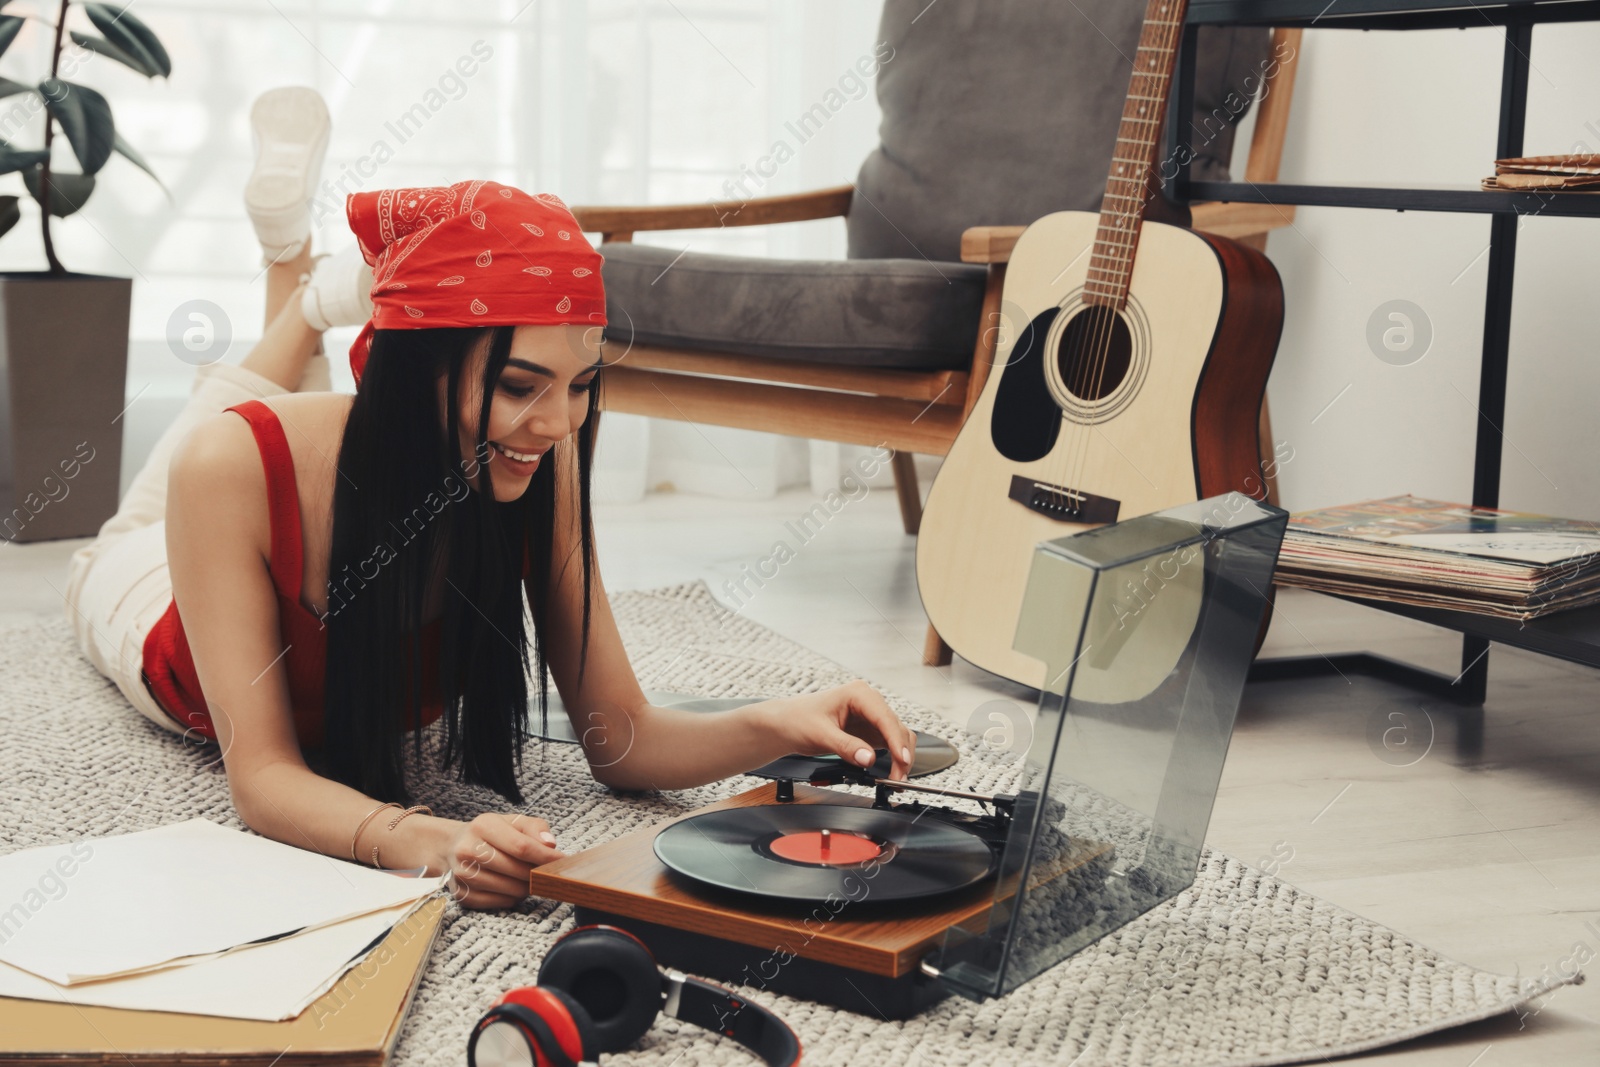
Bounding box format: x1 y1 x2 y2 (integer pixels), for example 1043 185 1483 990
917 211 1283 701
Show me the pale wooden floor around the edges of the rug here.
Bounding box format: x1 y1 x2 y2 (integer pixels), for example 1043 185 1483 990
0 490 1600 1067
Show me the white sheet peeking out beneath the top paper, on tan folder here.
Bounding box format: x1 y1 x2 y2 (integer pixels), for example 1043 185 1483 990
0 899 444 1022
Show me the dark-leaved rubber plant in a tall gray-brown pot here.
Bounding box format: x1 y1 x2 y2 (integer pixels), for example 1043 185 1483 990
0 0 173 541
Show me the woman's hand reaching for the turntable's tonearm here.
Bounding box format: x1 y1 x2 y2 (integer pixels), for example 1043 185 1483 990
752 678 917 781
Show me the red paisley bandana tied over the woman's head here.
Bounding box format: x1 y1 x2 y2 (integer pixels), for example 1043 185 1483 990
344 181 605 384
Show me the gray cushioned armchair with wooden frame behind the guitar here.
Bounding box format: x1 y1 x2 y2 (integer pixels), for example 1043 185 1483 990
574 0 1291 662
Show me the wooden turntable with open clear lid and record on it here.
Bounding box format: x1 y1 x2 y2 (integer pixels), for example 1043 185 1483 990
530 494 1288 1017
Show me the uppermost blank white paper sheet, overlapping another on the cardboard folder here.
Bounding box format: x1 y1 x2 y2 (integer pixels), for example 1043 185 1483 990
0 819 446 985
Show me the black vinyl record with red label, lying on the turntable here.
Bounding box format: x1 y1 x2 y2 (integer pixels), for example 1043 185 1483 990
654 803 995 902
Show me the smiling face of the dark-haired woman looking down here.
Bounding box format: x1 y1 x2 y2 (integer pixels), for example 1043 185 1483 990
438 325 600 502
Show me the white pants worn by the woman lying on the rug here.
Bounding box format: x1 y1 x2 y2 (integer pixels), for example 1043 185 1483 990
66 355 333 734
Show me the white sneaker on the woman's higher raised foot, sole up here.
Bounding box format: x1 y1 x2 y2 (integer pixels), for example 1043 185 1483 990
245 85 333 264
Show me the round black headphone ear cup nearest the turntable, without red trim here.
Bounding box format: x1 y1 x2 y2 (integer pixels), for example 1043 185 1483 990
539 926 661 1053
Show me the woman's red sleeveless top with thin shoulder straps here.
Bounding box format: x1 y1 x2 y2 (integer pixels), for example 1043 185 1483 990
144 400 443 747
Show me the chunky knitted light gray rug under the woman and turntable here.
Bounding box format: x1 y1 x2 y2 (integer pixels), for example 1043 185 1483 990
0 582 1562 1067
